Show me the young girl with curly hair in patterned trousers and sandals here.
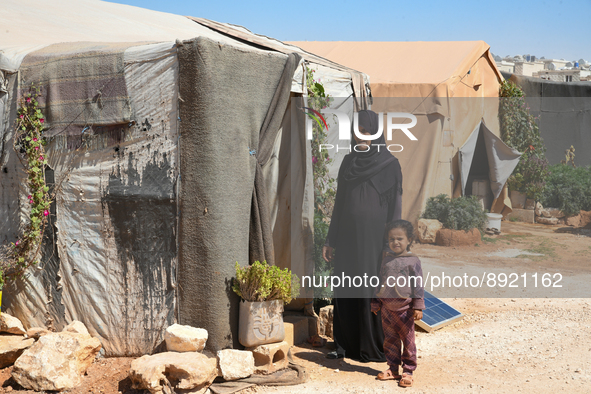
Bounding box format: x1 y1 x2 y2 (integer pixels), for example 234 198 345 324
371 220 425 387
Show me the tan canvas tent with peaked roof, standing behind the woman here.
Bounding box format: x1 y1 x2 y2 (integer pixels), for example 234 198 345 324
292 41 518 220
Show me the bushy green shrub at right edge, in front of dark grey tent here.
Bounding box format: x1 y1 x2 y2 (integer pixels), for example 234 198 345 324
540 164 591 216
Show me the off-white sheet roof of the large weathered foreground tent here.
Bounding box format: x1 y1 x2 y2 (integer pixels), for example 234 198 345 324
0 0 256 70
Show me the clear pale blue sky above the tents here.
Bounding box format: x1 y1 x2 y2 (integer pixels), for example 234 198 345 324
106 0 591 63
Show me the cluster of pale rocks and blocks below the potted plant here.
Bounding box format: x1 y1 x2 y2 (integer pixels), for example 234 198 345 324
129 324 289 394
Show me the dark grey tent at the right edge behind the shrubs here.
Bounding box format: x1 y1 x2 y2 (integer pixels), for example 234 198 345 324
506 74 591 166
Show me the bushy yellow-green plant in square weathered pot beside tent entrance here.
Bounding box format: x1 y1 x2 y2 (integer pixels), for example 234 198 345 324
232 261 299 347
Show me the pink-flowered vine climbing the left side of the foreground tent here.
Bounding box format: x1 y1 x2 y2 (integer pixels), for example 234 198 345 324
0 86 51 289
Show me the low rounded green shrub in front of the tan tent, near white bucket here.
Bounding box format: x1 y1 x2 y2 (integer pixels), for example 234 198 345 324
421 194 488 231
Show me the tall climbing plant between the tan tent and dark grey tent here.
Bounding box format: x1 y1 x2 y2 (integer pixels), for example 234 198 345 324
499 80 548 200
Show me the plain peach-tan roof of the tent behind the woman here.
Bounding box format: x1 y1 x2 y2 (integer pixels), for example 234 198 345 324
289 41 502 84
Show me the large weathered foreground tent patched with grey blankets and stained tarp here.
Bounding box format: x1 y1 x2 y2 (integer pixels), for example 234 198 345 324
0 0 368 355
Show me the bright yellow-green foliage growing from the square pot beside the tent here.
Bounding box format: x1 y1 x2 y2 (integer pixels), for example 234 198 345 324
232 261 300 304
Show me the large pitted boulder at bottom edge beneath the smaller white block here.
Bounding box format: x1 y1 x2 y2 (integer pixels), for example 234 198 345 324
129 351 218 394
